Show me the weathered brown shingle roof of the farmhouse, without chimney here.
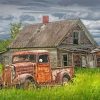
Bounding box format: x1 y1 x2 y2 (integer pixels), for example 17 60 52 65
9 20 95 48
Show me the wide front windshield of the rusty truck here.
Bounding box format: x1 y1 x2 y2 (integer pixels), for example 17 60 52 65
13 55 36 63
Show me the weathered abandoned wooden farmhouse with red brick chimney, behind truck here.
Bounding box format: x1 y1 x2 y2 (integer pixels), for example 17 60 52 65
0 16 97 68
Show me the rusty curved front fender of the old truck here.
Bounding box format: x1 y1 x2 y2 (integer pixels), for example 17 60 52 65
13 74 35 85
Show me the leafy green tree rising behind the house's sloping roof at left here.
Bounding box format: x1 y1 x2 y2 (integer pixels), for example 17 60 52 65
10 22 22 39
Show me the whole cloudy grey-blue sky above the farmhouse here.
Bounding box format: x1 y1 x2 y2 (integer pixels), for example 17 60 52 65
0 0 100 45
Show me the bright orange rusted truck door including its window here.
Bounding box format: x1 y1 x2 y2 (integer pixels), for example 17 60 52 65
36 54 51 83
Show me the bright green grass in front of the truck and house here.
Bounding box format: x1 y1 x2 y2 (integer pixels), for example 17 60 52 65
0 68 100 100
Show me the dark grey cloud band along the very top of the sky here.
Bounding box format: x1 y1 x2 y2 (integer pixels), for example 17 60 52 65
0 0 100 7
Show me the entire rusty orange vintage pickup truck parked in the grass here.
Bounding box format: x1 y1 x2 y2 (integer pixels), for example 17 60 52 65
2 50 74 87
